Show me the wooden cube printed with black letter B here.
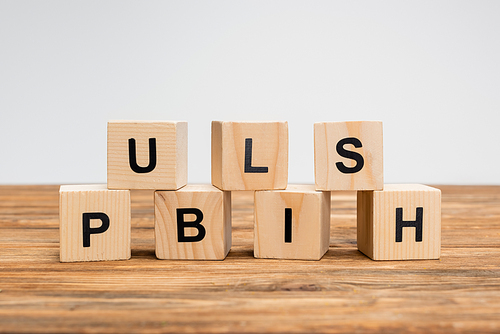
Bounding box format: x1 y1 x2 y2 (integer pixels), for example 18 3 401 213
155 185 231 260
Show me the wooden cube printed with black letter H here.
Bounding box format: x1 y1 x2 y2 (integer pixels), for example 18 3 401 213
358 184 441 260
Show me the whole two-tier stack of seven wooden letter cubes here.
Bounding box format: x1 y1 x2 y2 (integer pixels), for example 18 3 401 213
60 121 441 262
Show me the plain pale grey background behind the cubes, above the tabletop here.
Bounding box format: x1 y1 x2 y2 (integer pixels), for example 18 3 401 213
0 1 500 184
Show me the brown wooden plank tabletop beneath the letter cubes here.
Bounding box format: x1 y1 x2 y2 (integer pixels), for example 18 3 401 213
0 186 500 333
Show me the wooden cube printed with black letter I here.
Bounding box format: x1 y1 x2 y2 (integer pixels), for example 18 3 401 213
254 185 330 260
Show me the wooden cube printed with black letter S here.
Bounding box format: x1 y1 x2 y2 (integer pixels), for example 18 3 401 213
314 121 384 190
